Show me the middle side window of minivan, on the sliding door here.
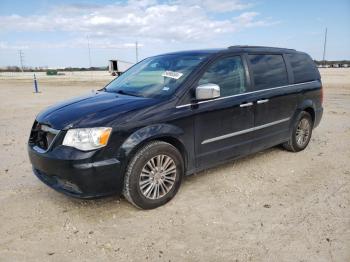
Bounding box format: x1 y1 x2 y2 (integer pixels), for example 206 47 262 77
248 55 288 90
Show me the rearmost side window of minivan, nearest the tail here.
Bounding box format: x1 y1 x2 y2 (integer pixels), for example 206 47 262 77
287 53 320 84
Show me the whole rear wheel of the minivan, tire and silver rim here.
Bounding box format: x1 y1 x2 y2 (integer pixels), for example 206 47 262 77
282 111 313 152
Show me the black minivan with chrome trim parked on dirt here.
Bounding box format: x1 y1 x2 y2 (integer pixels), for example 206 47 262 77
28 46 323 209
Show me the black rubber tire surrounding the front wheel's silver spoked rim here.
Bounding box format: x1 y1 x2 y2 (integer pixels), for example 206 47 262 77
123 141 184 209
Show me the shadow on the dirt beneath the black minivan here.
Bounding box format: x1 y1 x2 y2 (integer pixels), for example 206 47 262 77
45 146 290 220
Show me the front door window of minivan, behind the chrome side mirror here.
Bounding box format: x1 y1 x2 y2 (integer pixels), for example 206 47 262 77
198 56 246 96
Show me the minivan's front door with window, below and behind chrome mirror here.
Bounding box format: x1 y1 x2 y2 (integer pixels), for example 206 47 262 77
194 55 254 168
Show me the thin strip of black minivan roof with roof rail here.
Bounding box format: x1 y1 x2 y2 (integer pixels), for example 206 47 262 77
162 45 297 54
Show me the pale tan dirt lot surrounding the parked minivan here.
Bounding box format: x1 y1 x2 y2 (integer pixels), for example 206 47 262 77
0 69 350 262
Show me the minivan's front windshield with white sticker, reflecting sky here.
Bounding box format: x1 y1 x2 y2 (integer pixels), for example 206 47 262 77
105 54 208 97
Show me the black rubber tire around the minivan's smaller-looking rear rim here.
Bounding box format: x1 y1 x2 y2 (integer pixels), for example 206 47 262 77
282 111 313 152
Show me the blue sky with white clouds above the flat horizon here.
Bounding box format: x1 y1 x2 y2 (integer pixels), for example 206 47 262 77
0 0 350 67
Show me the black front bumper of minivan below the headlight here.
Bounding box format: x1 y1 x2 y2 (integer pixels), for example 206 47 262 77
28 145 123 198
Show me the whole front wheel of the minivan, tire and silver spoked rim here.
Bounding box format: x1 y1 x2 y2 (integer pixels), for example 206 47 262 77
123 141 184 209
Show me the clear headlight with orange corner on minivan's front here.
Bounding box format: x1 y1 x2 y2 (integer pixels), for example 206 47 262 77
63 127 112 151
